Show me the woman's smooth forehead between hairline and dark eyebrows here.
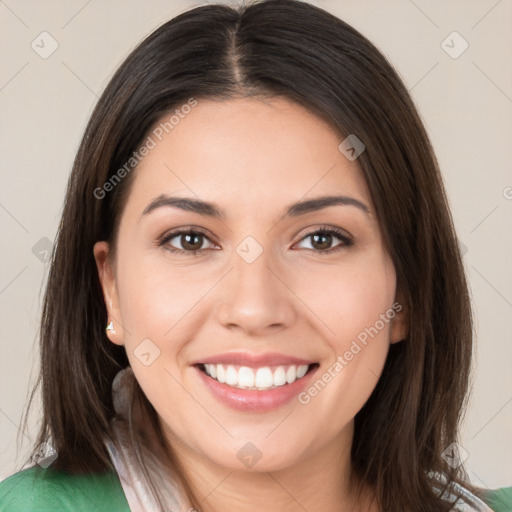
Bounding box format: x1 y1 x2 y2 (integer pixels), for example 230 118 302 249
124 98 372 219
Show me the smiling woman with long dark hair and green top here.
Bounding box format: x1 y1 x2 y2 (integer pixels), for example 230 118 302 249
0 0 511 512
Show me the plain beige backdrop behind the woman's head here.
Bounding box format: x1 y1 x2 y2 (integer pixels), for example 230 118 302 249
0 0 512 487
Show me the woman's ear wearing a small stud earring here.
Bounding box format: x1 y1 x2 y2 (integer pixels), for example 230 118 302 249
93 241 124 345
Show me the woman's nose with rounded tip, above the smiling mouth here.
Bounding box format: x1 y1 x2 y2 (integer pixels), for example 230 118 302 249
217 247 297 336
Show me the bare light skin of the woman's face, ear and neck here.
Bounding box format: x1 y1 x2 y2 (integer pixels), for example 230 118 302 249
94 98 407 512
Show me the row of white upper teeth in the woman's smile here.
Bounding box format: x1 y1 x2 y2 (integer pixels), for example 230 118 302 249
204 364 309 390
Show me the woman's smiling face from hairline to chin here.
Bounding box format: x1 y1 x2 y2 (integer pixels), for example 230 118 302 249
94 99 406 471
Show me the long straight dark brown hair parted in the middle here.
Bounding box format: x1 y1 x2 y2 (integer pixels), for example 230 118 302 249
19 0 484 512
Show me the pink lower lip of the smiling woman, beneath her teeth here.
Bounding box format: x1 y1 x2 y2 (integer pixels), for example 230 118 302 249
195 366 318 412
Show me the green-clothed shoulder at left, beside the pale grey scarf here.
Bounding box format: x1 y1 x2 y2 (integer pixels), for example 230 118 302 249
0 466 130 512
